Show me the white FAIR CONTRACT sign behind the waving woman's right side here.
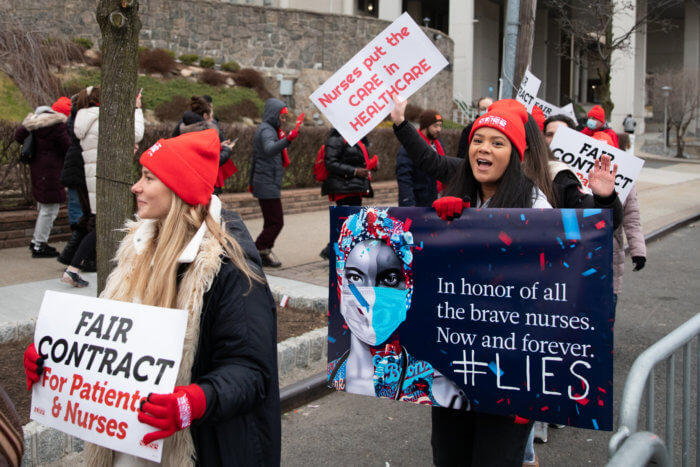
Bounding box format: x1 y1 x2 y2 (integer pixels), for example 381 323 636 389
549 126 644 203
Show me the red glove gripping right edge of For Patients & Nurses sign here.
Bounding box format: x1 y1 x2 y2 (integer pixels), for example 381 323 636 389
138 384 207 444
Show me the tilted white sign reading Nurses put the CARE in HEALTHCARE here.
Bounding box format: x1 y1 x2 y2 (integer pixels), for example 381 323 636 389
310 13 448 145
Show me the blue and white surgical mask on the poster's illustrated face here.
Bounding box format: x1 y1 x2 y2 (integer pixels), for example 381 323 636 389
340 284 408 345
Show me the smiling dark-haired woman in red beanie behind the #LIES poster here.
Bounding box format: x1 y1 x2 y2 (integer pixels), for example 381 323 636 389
391 97 551 467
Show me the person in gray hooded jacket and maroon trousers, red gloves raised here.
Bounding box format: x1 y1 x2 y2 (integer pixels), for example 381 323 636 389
250 98 299 268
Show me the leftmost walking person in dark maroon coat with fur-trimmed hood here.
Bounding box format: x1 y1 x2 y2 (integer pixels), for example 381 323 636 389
15 101 70 258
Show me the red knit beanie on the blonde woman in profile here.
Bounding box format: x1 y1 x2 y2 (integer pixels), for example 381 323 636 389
139 128 221 206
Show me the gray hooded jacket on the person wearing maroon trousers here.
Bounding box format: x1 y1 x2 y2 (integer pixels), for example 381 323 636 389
250 98 289 199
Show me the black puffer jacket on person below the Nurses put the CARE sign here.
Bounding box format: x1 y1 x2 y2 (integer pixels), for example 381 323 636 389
321 128 372 197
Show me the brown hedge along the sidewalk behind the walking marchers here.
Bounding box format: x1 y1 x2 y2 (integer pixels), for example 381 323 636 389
0 120 468 209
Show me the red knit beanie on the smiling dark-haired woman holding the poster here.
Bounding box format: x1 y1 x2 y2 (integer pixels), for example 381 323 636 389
469 99 527 162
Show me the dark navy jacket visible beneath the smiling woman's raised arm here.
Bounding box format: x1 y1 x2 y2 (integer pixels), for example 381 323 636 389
396 146 438 207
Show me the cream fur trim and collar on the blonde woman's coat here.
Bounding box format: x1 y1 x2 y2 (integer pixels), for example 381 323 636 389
85 196 224 467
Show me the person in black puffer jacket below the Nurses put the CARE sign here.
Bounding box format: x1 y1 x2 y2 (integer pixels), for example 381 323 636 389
320 128 377 259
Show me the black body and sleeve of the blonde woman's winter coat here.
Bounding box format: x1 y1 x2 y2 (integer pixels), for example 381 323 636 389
190 260 281 466
